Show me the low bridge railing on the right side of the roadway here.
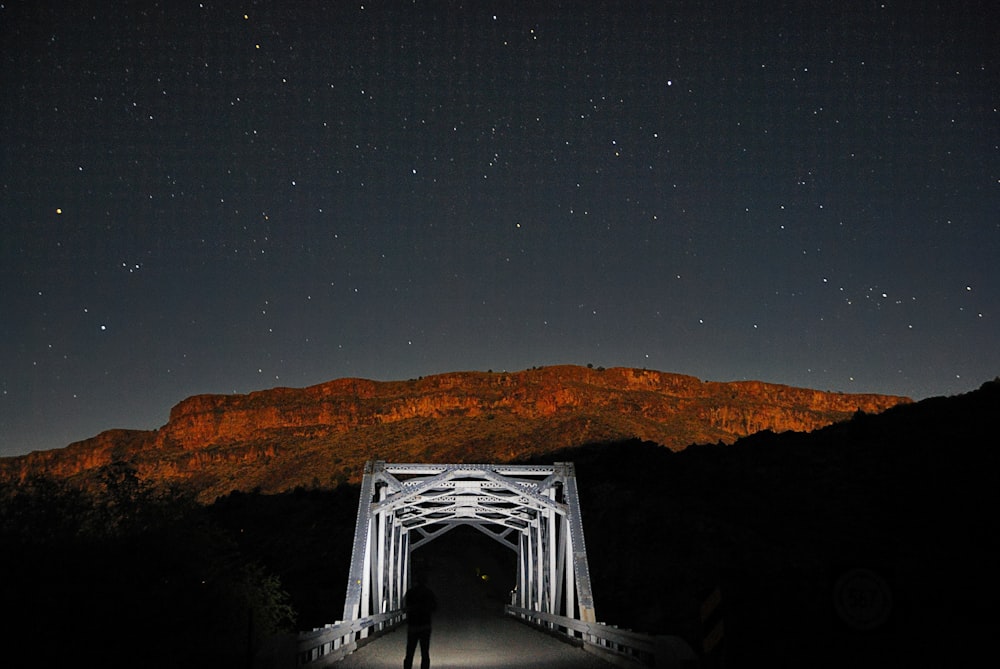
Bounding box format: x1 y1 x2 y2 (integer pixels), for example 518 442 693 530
506 604 699 668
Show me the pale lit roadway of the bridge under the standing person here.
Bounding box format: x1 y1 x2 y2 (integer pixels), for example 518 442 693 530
335 614 613 669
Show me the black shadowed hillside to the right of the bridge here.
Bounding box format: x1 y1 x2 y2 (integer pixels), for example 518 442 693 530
551 382 1000 667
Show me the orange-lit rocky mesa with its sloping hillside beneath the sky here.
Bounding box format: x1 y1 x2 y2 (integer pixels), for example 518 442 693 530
0 366 909 497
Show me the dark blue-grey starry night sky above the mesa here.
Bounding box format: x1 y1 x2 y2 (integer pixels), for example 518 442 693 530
0 0 1000 455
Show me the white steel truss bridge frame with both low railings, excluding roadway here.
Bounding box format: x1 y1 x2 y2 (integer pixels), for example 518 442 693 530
297 460 694 669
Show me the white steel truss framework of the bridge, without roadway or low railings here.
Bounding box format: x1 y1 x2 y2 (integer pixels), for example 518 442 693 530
344 460 596 622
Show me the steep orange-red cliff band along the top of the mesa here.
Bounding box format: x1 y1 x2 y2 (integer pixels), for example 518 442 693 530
158 367 906 449
